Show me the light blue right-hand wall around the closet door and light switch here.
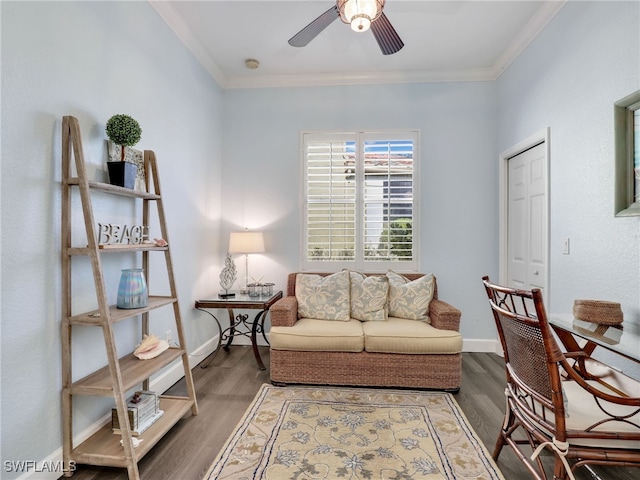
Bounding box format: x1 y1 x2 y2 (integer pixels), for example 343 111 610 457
498 2 640 378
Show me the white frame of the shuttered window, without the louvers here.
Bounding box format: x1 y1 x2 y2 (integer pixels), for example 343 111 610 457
300 129 421 272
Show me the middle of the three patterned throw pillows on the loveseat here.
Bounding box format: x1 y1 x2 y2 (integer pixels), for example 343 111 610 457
350 272 389 321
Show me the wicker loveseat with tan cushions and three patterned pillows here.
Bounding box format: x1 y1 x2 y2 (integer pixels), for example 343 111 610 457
270 270 462 392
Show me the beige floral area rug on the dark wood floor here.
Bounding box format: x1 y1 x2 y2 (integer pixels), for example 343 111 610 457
205 384 504 480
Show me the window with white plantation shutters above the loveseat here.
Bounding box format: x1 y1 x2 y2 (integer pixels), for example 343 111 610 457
302 131 418 271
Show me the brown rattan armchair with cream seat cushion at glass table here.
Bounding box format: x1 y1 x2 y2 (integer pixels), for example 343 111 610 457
483 277 640 480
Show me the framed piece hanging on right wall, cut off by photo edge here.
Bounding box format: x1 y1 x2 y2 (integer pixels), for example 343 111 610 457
613 90 640 217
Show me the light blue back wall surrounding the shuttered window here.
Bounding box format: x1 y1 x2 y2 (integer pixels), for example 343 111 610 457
222 82 498 339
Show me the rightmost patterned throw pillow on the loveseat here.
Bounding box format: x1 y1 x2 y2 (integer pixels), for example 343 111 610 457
387 271 434 321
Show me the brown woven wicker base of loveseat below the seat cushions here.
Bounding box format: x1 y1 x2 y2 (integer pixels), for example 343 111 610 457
270 349 462 392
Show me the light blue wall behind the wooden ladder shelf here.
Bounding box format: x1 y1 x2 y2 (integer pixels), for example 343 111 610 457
0 2 222 478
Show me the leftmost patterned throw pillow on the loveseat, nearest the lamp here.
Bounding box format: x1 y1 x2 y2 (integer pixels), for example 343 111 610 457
296 271 350 322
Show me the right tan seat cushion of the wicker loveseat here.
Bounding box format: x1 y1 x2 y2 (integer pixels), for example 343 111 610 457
362 317 462 354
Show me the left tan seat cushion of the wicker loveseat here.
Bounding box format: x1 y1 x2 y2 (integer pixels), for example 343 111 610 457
269 318 362 352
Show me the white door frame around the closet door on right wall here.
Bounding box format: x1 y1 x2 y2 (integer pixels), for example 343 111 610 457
498 127 551 296
